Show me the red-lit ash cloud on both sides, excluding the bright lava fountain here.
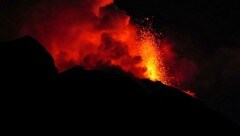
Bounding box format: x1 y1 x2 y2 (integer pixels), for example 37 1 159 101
1 0 200 87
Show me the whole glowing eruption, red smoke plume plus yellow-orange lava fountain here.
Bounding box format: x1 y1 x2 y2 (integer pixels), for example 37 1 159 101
23 0 196 88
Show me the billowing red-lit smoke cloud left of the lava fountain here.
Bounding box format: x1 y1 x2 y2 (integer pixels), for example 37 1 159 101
20 0 144 73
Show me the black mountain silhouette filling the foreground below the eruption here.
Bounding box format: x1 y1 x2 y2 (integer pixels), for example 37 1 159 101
0 37 239 135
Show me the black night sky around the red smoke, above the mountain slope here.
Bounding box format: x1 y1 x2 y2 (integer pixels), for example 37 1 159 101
0 0 240 123
